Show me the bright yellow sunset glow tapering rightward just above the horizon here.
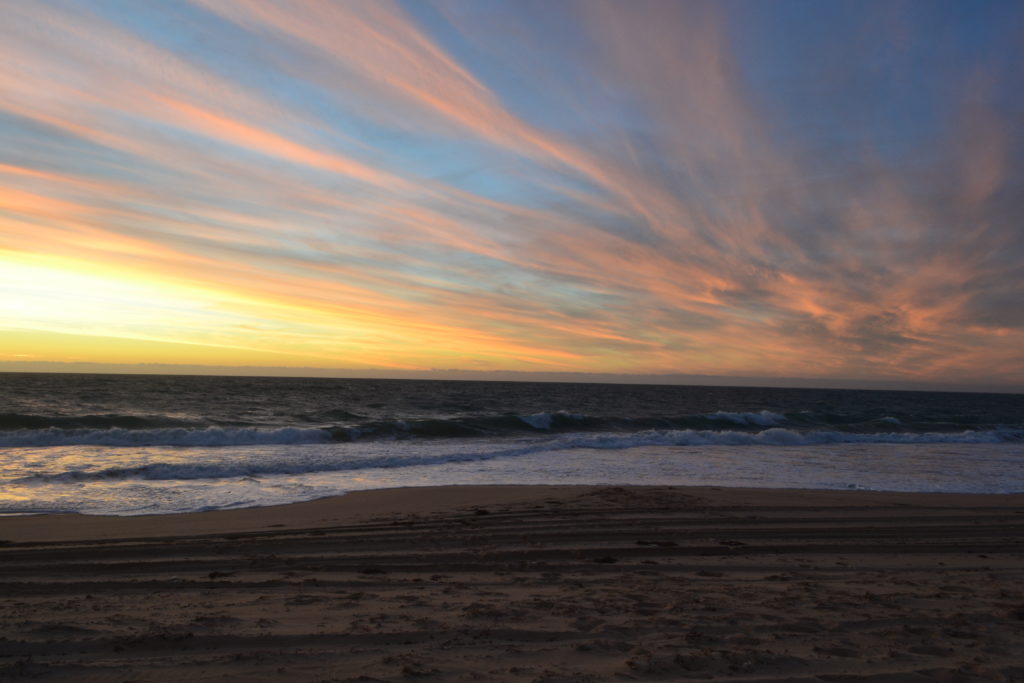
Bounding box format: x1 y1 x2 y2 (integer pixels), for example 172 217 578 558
0 250 593 370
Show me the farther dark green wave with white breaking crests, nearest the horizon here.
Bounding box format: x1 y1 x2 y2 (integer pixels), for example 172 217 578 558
0 410 1022 447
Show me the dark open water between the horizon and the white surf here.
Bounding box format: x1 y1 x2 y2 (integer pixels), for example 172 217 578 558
0 374 1024 445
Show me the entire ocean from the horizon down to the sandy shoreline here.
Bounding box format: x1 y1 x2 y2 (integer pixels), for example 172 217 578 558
0 373 1024 515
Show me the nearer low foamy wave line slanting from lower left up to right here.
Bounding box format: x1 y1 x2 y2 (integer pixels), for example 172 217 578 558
14 427 1024 483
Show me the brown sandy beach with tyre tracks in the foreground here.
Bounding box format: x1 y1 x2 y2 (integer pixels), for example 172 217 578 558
0 486 1024 682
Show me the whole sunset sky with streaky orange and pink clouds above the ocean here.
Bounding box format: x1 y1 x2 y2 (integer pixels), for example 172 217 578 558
0 0 1024 390
